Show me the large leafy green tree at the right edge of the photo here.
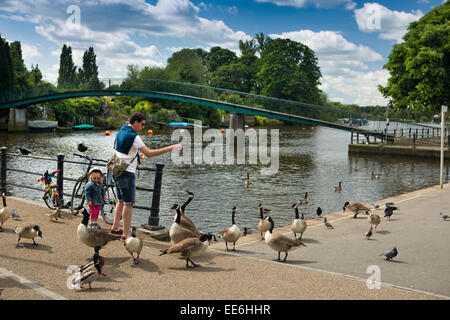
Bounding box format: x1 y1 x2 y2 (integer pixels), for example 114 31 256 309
378 1 450 114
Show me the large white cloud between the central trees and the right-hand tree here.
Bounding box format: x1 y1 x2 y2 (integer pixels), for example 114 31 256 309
270 30 388 105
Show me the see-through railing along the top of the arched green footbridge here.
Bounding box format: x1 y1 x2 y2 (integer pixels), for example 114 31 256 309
0 78 446 137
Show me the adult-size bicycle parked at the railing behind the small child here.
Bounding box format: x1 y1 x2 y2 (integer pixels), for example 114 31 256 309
70 153 117 224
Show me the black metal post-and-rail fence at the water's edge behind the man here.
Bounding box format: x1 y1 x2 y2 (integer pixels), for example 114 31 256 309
0 147 164 230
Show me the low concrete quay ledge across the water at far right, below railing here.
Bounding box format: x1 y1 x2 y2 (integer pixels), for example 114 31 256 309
348 144 450 159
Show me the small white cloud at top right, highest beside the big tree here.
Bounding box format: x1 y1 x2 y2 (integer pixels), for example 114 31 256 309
354 2 423 42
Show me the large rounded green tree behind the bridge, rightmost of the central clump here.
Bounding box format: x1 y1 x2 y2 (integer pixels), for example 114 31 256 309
258 39 322 103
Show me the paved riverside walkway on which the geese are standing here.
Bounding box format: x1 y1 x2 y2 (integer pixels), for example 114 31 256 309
0 184 450 300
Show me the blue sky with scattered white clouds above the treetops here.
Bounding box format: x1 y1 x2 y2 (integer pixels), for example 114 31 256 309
0 0 445 105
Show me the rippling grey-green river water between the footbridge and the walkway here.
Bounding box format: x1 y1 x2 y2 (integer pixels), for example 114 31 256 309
0 126 449 233
